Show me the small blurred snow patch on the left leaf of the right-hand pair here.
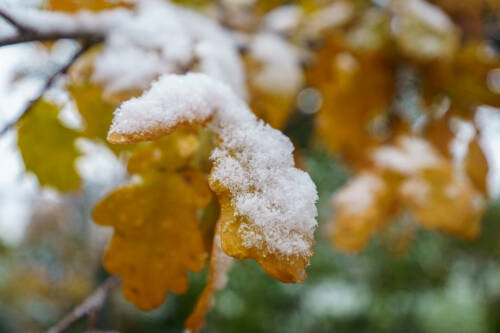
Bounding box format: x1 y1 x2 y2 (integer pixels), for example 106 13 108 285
333 173 385 215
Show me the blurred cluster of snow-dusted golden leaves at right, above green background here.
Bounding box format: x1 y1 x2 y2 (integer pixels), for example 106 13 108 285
329 136 485 253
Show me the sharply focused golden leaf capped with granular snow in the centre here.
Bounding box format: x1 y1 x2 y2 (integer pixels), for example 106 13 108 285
108 73 317 282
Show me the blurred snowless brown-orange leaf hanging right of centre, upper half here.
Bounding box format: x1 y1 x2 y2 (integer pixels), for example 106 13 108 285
308 36 394 167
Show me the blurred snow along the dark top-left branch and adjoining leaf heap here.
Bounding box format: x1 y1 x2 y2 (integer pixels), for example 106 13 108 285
9 0 246 98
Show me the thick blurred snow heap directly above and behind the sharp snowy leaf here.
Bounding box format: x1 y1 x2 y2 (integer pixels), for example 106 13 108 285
94 0 246 98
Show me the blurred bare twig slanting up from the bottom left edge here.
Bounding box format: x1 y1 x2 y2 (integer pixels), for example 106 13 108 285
46 276 120 333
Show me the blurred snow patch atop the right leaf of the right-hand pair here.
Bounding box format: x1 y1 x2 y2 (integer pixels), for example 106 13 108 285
372 136 443 175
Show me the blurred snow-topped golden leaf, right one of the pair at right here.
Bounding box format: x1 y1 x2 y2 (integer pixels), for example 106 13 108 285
373 136 484 239
